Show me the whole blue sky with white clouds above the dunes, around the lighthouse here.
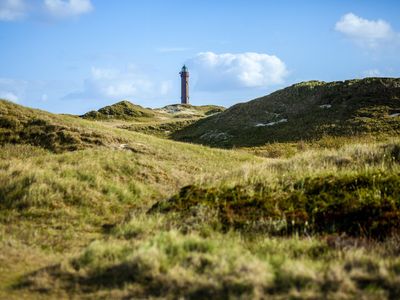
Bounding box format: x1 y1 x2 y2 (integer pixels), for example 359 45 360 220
0 0 400 114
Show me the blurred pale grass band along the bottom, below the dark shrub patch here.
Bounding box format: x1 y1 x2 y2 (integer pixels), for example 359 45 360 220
19 216 400 299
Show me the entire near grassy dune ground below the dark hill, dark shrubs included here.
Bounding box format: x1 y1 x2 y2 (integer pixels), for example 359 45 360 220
0 101 400 299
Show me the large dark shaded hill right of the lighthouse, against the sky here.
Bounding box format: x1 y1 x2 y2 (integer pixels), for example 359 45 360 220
173 78 400 147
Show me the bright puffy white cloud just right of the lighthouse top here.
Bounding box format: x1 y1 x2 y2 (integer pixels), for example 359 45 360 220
188 52 288 90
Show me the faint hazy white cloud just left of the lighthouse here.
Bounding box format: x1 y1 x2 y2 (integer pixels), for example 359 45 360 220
65 66 172 100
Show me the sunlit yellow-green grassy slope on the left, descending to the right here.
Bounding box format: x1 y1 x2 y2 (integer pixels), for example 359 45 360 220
0 100 258 299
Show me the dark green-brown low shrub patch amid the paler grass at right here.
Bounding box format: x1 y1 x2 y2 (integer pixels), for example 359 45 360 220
150 172 400 238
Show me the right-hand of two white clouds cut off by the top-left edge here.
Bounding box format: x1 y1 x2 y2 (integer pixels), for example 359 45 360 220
44 0 93 17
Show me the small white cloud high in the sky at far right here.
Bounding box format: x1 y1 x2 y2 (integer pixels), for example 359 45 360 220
335 13 399 48
